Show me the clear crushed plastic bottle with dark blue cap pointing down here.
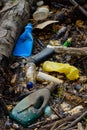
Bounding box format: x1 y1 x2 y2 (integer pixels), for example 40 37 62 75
26 62 36 89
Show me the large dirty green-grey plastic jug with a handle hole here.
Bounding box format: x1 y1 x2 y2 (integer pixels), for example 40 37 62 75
10 82 55 127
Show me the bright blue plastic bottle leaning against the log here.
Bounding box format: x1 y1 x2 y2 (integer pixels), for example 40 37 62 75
13 23 33 57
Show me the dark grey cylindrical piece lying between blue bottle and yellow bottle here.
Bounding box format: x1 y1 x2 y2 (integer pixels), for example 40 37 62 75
30 47 54 65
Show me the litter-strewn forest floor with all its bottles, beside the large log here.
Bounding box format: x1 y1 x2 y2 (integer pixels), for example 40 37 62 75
0 0 87 130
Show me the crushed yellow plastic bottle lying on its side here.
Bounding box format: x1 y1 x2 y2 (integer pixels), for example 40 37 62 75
43 61 79 80
